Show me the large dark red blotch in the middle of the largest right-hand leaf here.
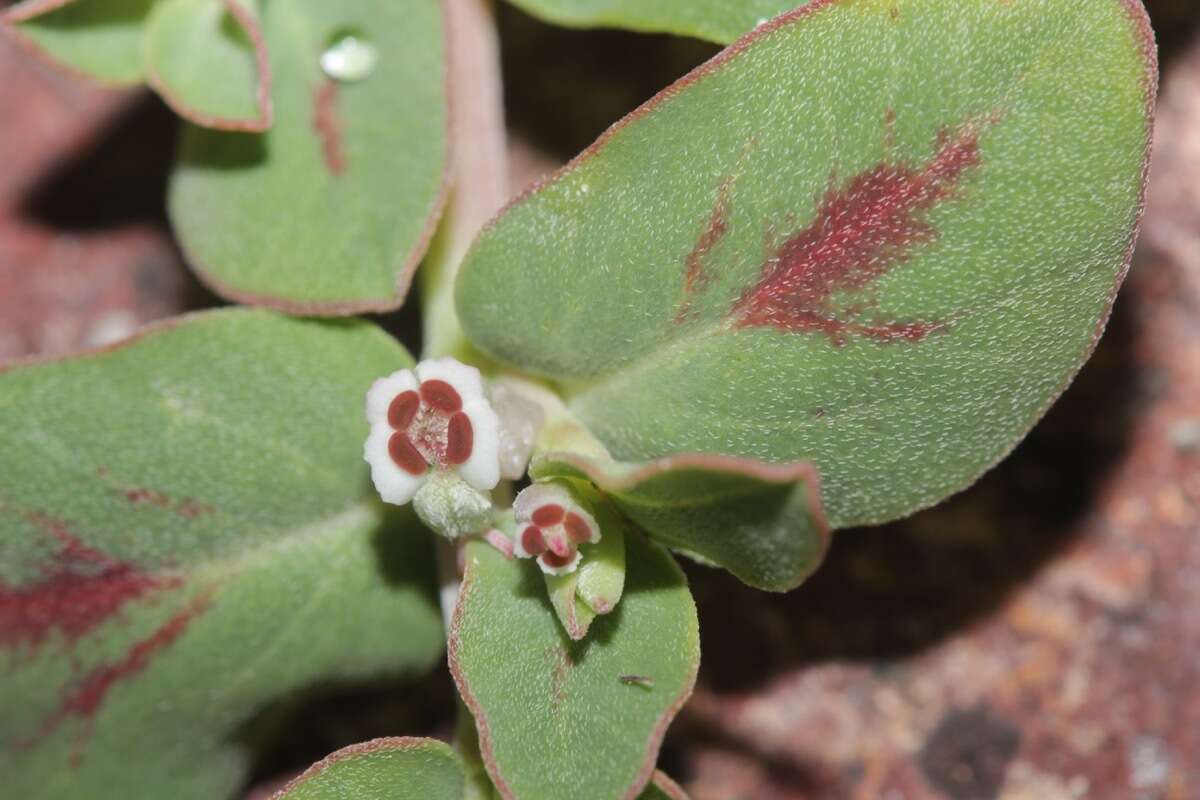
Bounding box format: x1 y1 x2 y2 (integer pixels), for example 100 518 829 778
731 125 980 344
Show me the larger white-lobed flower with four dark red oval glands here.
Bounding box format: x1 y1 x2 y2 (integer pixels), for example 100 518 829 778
364 359 500 505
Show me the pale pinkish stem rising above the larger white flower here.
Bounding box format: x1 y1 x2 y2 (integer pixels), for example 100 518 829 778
421 0 509 362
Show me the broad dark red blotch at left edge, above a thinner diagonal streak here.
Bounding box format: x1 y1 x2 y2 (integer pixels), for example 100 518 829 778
0 513 182 652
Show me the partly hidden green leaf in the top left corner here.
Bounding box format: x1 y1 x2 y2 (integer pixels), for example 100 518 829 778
4 0 156 84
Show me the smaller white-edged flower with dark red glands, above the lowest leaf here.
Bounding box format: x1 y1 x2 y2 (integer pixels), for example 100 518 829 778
512 483 600 576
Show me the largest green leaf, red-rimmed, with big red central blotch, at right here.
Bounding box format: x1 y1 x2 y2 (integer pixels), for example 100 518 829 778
457 0 1157 527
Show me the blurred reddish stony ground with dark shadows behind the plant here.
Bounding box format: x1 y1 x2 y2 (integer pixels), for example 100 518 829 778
0 0 1200 800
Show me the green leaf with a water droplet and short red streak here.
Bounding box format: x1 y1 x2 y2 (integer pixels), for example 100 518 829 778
169 0 446 314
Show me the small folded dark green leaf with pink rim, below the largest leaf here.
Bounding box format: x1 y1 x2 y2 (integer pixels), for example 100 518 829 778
540 453 829 591
